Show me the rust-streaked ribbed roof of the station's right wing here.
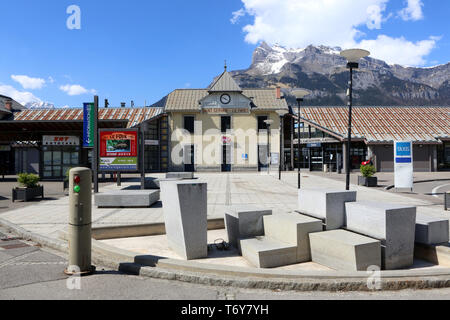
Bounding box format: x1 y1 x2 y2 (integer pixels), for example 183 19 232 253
294 107 450 143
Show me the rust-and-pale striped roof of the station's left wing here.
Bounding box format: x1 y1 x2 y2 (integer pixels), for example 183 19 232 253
10 108 164 128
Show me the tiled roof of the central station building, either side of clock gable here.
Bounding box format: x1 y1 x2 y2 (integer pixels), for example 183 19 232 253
166 89 288 112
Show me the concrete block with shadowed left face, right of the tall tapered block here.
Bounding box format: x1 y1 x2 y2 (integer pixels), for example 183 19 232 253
225 205 272 249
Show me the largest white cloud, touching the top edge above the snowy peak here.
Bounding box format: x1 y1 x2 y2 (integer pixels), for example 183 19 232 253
237 0 389 48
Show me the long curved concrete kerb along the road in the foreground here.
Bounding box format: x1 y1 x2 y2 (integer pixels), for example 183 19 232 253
0 218 450 291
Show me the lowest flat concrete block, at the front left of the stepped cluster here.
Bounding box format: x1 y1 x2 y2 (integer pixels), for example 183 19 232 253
241 237 297 268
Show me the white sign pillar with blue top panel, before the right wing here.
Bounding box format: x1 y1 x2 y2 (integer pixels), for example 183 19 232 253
394 141 414 190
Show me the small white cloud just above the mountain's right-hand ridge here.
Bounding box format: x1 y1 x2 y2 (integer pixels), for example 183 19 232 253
359 35 439 66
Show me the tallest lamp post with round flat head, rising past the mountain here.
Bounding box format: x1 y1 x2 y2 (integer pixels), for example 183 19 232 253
341 49 370 190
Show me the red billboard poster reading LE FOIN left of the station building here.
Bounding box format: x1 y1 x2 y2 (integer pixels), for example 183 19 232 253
99 130 139 171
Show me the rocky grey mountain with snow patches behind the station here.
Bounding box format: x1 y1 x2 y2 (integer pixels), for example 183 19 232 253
231 42 450 105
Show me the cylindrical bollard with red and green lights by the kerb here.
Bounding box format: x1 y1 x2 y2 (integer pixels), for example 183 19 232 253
64 168 95 275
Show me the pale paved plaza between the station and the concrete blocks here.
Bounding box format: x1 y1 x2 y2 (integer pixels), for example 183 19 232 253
0 172 448 242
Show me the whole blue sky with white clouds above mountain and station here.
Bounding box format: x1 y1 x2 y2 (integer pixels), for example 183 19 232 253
0 0 450 107
